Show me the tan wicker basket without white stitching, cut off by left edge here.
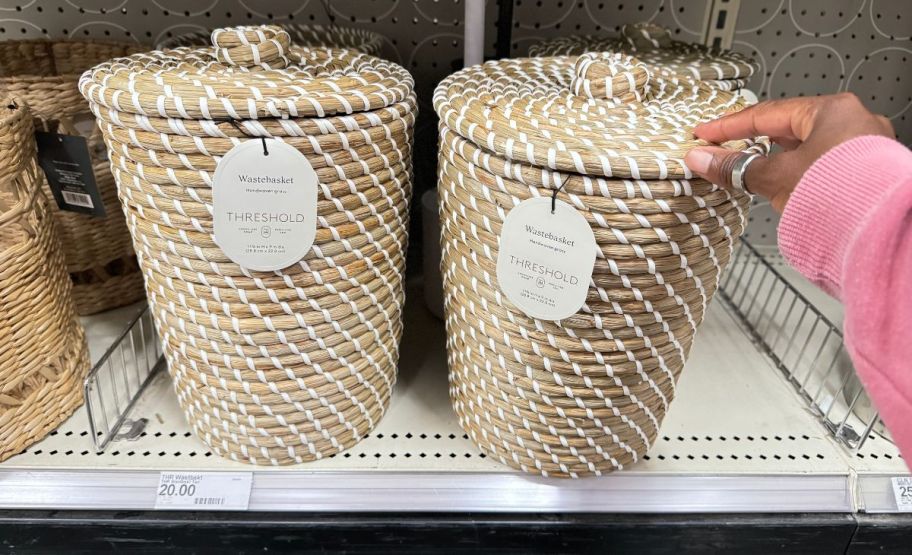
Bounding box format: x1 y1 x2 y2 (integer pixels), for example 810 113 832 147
0 97 89 461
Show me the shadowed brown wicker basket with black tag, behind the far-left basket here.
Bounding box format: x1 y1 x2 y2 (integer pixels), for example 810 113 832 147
0 40 143 314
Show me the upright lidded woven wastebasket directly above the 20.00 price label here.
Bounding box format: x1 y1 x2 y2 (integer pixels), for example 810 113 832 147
80 26 416 465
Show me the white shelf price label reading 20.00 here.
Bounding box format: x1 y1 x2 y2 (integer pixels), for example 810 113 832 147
155 472 253 511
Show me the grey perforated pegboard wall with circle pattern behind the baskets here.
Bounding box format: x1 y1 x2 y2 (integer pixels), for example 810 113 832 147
0 0 912 246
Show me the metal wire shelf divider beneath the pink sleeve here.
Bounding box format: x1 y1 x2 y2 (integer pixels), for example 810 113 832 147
719 240 880 449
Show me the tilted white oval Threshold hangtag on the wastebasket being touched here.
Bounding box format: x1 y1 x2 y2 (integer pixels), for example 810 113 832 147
497 197 598 320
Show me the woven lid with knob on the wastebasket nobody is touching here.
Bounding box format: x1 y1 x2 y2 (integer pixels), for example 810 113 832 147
79 25 414 120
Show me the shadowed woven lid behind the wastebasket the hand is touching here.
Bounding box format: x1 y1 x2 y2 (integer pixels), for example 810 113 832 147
529 23 757 91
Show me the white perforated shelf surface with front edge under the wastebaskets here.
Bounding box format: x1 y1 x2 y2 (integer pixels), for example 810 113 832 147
0 272 908 512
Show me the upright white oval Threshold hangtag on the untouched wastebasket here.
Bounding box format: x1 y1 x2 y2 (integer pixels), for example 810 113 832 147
212 139 318 271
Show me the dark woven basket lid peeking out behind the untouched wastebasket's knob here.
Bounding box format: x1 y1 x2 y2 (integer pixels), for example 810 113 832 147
158 23 383 56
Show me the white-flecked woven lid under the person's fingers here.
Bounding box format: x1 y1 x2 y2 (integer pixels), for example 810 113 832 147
434 53 750 179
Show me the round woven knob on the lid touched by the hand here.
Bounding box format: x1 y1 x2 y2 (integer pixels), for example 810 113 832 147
570 52 650 102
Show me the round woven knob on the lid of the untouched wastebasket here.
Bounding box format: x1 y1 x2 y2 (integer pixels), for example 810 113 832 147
212 25 291 69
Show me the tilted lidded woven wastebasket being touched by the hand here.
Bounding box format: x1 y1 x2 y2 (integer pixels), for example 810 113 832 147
434 54 762 477
